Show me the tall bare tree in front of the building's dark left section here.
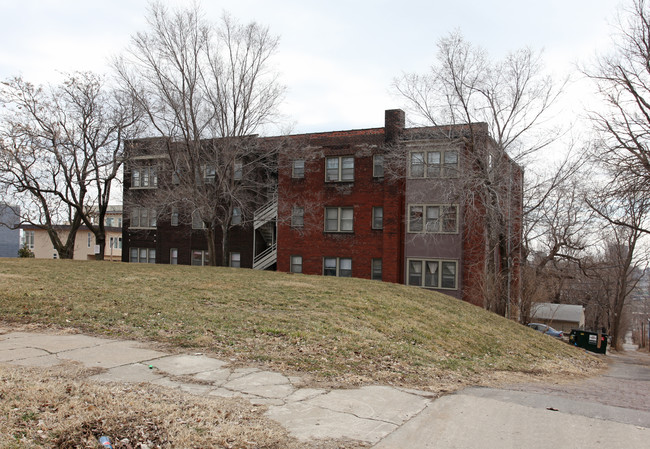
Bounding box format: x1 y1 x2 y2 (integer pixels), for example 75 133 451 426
115 3 284 265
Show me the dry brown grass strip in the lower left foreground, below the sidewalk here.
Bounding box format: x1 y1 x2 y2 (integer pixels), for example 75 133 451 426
0 363 365 449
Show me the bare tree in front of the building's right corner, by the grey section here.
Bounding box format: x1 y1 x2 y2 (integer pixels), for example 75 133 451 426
394 33 561 315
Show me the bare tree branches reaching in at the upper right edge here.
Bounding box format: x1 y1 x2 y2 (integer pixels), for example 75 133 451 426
584 0 650 233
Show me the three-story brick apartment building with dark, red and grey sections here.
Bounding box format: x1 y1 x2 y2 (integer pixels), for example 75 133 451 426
122 110 523 305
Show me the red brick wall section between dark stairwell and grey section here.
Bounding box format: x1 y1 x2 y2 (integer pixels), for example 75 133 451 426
277 130 404 282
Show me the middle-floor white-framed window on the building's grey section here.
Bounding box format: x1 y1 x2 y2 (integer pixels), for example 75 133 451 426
408 204 458 234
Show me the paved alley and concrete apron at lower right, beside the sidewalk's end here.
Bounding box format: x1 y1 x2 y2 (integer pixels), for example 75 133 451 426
374 346 650 449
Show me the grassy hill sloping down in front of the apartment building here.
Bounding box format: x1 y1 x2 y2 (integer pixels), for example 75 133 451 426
0 259 602 388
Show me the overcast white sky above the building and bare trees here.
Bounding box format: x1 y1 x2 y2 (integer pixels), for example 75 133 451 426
0 0 619 132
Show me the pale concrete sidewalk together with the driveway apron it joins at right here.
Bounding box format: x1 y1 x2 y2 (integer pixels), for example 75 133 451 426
0 329 650 449
